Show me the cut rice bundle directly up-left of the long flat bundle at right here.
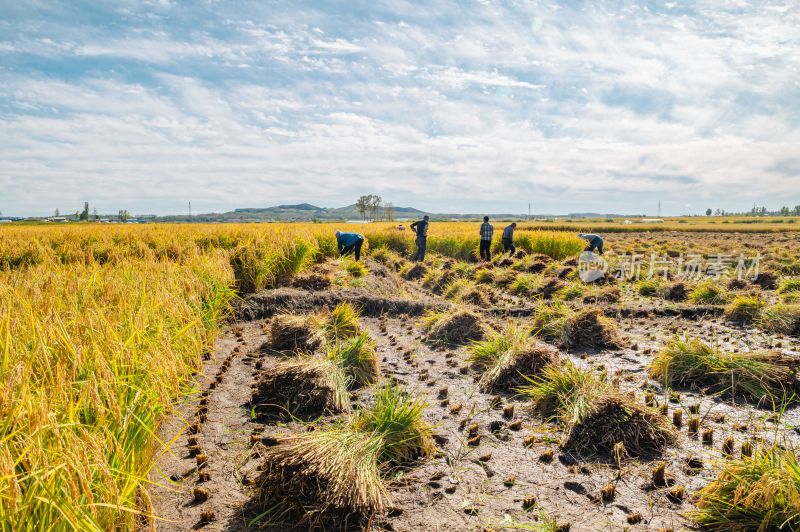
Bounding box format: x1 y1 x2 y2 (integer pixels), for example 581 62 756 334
533 302 624 349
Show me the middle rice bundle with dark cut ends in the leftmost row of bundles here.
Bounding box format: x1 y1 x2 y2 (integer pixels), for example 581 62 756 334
253 357 351 420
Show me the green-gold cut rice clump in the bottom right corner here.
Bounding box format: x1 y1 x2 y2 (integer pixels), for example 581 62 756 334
689 447 800 531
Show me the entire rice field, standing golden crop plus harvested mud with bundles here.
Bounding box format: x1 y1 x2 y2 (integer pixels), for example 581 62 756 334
0 222 800 530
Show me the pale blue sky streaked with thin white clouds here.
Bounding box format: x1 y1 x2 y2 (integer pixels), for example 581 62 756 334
0 0 800 215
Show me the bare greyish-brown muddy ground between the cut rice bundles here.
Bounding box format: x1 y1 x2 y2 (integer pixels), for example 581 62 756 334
143 244 800 531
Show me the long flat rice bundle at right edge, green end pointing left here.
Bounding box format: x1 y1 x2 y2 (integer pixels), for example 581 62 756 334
650 337 796 406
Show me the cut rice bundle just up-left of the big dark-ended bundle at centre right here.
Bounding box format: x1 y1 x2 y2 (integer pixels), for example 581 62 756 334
467 326 558 392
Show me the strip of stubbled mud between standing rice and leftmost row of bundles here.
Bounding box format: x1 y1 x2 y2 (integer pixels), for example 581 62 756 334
149 322 263 531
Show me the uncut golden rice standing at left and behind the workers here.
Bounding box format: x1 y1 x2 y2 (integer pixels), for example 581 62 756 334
0 218 592 530
